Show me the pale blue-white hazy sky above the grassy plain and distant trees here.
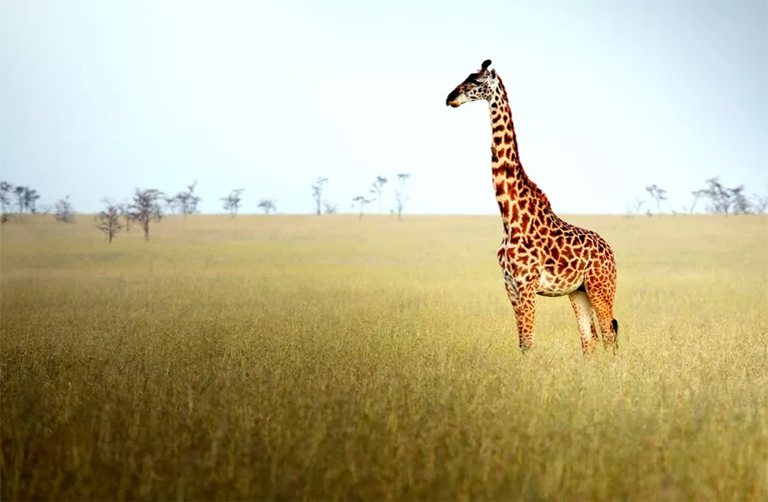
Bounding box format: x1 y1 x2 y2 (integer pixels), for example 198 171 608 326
0 0 768 213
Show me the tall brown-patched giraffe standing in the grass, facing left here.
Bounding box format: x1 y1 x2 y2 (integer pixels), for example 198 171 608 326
445 60 619 354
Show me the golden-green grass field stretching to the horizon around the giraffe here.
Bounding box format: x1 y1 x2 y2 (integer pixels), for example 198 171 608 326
0 215 768 501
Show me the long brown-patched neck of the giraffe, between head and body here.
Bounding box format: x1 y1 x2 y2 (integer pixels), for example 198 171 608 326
488 77 552 230
